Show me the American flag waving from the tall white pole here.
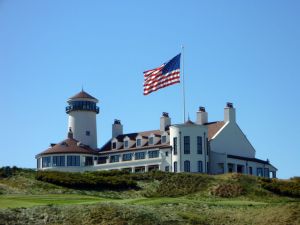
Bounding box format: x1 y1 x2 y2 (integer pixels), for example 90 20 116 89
144 54 181 95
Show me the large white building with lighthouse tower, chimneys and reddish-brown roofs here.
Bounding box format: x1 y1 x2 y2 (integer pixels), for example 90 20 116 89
36 91 277 177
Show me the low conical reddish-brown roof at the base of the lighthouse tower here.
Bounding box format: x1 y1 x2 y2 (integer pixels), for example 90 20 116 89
38 138 99 155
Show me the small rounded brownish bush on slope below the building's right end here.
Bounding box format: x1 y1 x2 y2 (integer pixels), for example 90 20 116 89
211 183 245 198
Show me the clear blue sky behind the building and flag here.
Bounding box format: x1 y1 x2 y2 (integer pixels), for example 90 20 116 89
0 0 300 178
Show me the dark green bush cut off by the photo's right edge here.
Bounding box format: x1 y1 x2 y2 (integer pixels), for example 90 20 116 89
260 178 300 198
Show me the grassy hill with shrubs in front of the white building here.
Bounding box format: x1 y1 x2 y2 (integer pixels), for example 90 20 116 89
0 168 300 225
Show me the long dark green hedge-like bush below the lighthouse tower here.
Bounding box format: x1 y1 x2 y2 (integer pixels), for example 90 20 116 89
36 171 137 189
